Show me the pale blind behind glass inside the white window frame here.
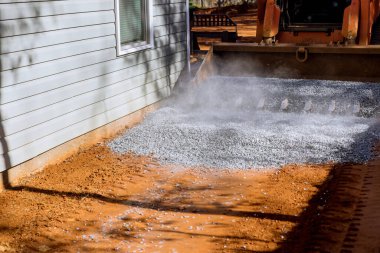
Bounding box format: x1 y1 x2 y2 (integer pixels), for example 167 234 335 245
119 0 146 45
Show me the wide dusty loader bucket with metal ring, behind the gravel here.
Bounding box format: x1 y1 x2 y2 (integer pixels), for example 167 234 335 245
194 43 380 83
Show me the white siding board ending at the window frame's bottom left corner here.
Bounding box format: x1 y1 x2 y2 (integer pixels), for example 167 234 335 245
1 48 116 87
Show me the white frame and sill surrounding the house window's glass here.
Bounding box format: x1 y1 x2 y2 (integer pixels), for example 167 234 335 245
115 0 154 56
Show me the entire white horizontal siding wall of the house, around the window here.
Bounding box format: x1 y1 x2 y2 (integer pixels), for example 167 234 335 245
0 0 186 172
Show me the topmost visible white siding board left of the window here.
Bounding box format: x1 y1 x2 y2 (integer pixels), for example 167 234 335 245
0 0 114 20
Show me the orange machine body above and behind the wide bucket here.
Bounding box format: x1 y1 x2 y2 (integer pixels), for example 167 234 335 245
257 0 380 45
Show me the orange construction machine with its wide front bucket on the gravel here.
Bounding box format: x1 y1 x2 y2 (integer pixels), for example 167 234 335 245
196 0 380 82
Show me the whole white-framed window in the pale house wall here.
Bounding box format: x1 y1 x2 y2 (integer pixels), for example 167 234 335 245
115 0 153 55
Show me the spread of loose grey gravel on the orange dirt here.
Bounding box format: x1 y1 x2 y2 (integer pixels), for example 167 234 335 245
109 77 380 168
